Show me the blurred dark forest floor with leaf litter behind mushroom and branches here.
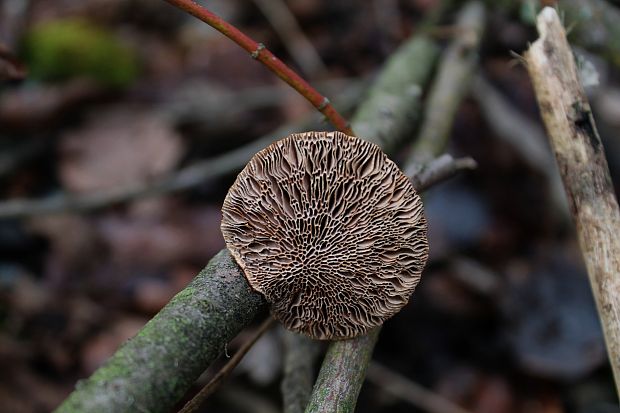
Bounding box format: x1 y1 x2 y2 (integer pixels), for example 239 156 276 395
0 0 620 413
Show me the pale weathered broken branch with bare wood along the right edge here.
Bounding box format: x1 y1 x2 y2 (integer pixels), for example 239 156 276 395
525 7 620 394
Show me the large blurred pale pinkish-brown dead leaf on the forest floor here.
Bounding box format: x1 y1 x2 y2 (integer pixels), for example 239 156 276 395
60 106 183 192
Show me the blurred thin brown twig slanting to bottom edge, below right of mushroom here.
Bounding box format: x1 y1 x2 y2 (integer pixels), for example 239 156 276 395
367 361 470 413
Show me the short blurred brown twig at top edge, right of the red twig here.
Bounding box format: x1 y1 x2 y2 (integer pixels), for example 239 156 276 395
253 0 327 77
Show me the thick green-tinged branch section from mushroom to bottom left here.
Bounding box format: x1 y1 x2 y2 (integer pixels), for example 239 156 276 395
56 250 267 413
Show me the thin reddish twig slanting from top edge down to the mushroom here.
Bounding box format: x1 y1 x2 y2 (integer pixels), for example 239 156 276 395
166 0 353 135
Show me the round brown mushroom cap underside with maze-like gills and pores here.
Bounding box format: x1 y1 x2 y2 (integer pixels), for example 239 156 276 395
221 132 428 339
